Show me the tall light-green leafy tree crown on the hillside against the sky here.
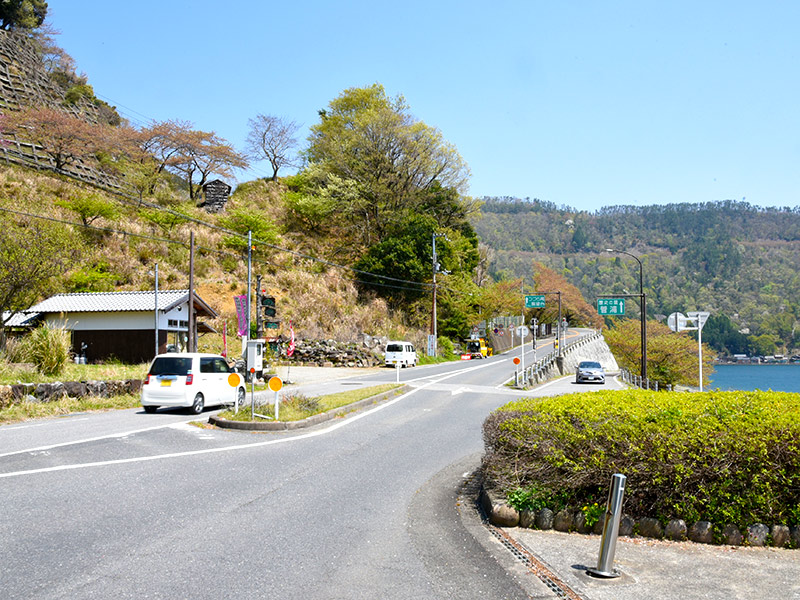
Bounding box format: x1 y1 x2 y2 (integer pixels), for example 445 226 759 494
305 84 469 247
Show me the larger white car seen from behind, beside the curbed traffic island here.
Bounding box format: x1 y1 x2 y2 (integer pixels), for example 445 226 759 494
142 352 246 415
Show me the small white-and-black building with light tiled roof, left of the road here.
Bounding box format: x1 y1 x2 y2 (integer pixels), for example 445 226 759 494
20 290 217 363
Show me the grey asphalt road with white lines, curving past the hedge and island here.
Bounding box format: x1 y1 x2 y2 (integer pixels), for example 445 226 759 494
0 332 614 599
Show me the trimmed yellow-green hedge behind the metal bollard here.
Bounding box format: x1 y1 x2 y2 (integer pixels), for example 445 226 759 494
484 390 800 527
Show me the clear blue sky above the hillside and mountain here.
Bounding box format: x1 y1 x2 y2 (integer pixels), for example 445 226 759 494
48 0 800 211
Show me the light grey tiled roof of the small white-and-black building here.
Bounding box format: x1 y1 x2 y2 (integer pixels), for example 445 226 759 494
28 290 189 313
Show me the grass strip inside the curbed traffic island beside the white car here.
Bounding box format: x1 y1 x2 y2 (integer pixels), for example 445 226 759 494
219 383 402 421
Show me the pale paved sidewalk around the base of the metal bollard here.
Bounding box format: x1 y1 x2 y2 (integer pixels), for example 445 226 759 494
502 527 800 600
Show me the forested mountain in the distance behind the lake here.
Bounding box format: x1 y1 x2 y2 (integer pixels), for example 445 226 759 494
473 198 800 354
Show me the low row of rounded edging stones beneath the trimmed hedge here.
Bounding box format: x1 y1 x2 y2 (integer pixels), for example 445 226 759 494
479 488 800 548
